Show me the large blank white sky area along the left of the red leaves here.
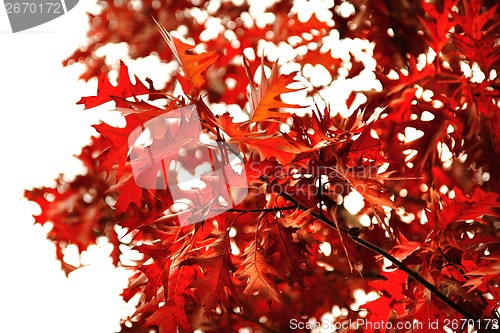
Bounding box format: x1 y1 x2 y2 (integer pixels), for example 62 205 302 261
0 0 133 333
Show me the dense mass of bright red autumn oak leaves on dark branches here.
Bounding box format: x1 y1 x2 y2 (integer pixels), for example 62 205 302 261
25 0 500 333
